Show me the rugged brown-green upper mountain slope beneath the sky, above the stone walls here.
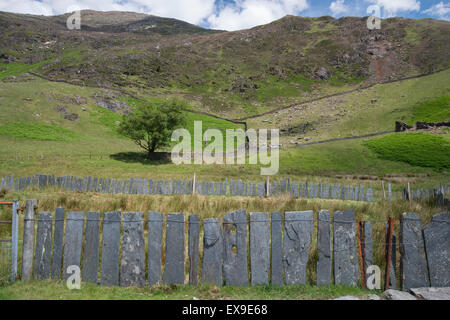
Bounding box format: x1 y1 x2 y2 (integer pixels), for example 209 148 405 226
0 11 450 118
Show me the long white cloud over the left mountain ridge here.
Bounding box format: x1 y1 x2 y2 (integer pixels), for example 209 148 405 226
0 0 214 24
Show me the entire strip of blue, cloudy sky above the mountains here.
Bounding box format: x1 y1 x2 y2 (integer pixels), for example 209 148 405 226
0 0 450 30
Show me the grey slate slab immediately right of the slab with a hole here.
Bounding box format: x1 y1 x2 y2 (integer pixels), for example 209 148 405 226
250 212 270 286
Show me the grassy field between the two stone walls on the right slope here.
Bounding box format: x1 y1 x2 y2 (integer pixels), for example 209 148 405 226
248 70 450 147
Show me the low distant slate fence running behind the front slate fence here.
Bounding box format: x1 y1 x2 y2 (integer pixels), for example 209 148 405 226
0 174 373 202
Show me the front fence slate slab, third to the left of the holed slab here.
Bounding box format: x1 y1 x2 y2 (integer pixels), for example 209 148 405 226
163 213 184 284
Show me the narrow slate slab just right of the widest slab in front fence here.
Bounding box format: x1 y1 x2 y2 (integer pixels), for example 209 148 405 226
317 210 332 286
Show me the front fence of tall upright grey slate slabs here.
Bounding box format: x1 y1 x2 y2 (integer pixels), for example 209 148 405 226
22 208 450 289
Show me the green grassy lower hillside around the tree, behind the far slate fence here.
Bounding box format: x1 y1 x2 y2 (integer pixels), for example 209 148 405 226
0 71 450 185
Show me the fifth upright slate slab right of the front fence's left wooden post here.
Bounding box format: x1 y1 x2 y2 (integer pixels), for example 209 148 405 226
100 211 122 286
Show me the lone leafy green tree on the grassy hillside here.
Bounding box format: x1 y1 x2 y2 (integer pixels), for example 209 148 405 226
118 101 186 160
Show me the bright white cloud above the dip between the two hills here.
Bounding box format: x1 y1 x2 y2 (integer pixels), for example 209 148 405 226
207 0 308 31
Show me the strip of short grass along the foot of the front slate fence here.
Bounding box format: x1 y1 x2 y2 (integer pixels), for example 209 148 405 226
0 281 379 300
